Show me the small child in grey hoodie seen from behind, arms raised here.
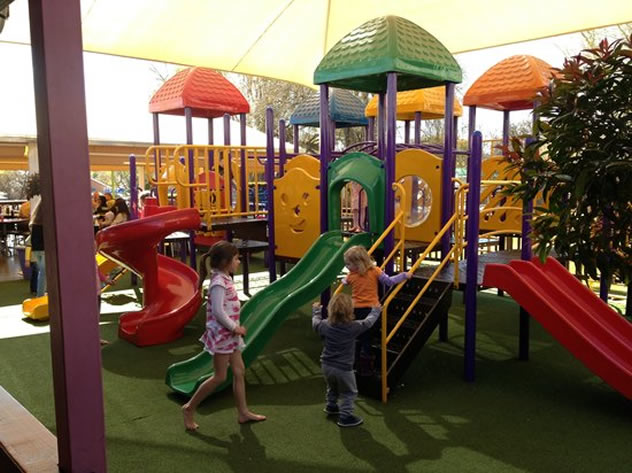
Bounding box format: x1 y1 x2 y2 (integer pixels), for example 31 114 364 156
312 293 382 427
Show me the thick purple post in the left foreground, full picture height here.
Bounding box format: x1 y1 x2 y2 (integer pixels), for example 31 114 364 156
29 0 106 473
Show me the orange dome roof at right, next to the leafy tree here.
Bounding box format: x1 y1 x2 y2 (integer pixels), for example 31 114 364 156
463 55 553 111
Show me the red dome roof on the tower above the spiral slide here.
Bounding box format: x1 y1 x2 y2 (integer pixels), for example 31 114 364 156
149 67 250 118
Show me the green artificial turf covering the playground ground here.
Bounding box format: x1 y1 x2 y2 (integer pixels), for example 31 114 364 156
0 268 632 473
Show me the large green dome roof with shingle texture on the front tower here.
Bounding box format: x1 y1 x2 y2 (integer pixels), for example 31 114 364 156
314 16 462 93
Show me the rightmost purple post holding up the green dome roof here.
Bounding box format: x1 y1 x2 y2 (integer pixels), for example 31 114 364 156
441 82 454 258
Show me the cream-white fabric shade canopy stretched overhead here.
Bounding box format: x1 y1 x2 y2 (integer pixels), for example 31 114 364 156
0 0 632 86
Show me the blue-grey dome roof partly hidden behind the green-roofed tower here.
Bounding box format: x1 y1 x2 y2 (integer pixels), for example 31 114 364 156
290 89 369 128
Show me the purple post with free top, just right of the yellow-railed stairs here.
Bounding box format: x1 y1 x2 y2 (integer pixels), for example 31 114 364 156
464 131 483 382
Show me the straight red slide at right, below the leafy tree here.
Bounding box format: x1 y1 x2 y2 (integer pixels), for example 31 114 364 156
483 258 632 399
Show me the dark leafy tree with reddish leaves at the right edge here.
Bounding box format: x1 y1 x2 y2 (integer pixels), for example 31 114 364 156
507 35 632 307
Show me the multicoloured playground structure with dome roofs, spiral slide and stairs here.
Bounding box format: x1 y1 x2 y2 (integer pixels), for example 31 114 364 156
8 17 625 401
